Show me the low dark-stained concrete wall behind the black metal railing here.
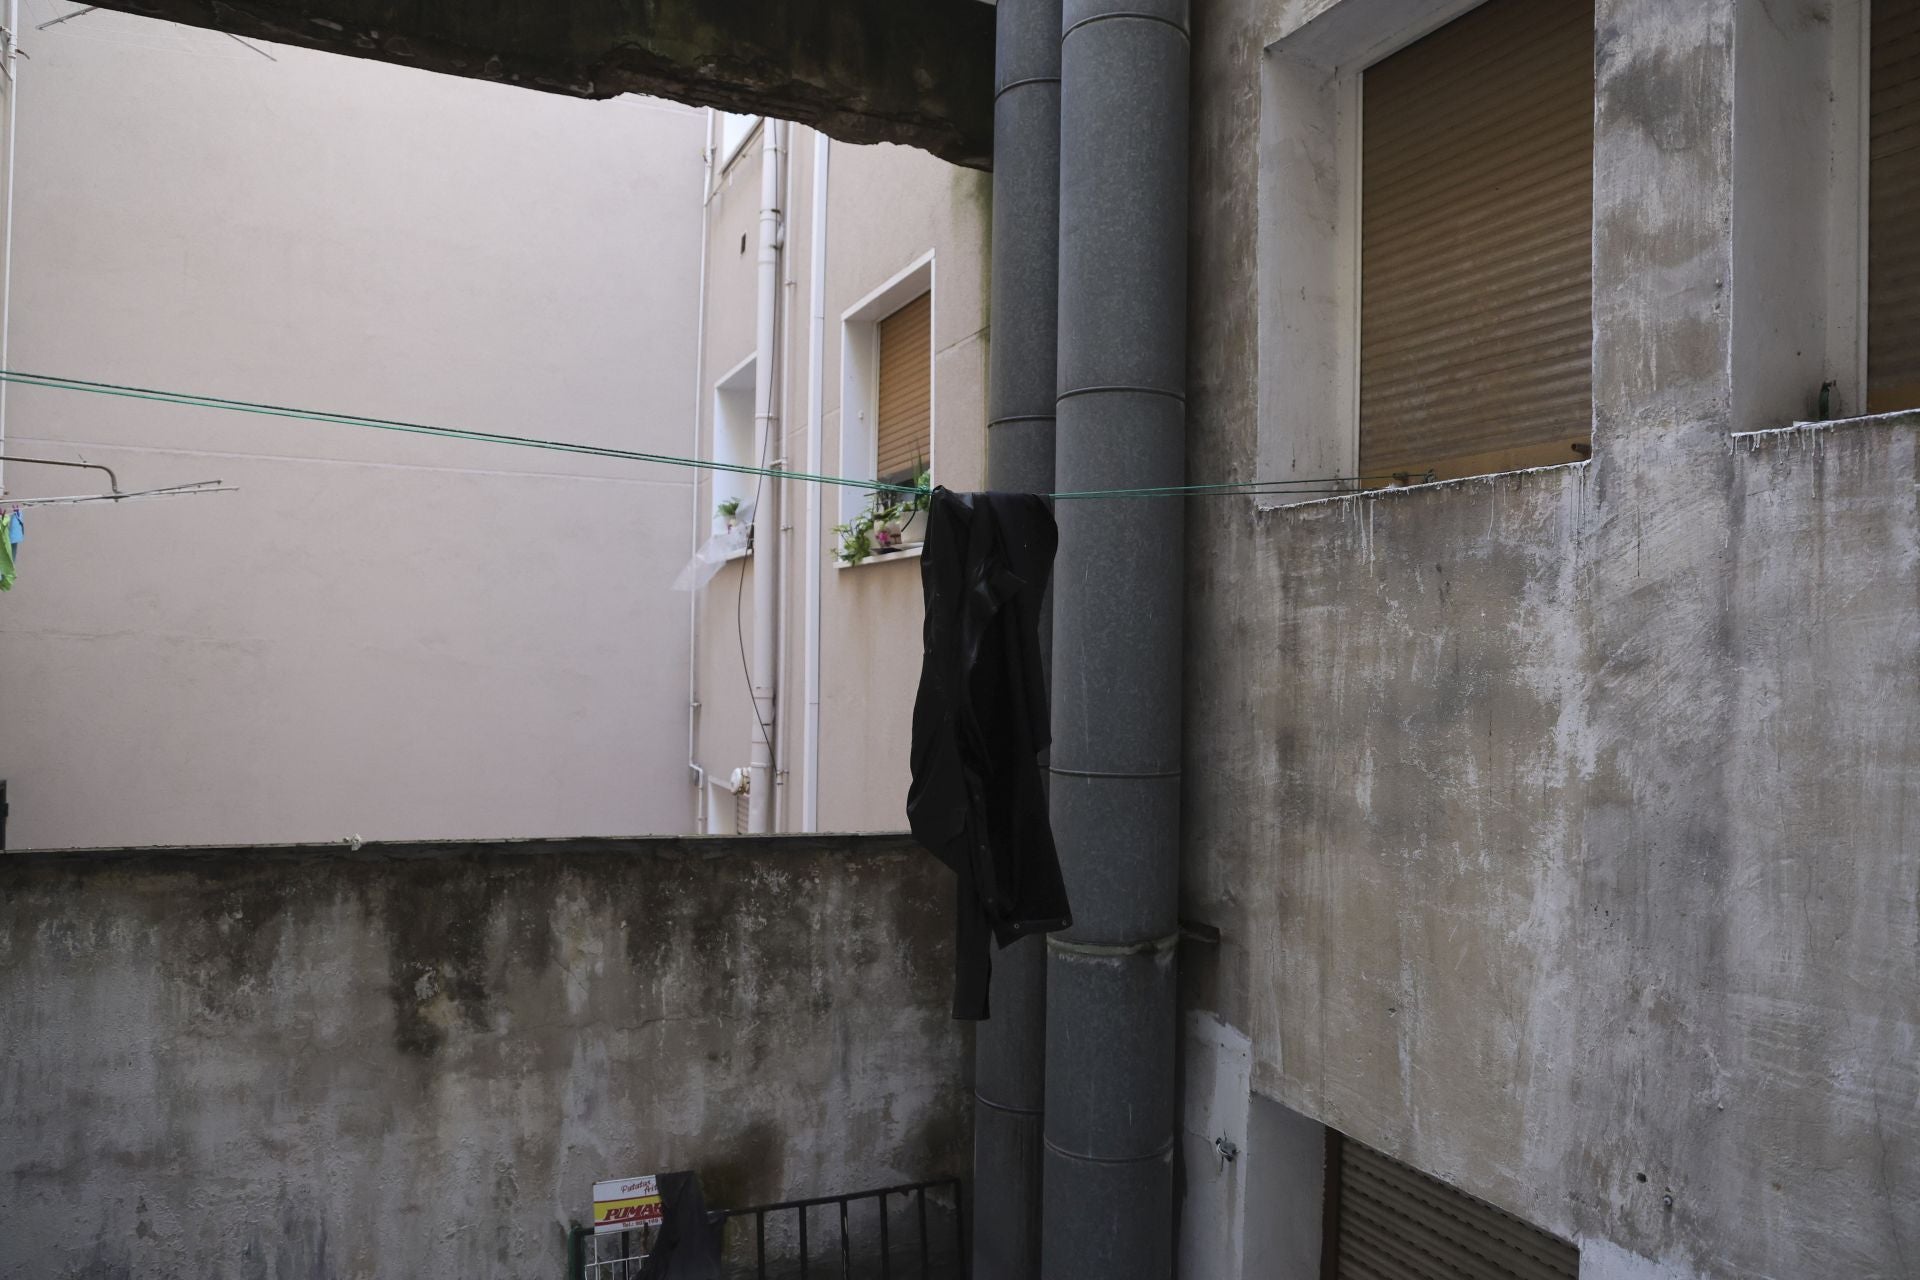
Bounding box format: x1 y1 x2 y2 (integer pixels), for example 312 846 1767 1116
0 837 972 1278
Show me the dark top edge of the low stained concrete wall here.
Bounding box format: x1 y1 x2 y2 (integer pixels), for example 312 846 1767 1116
0 831 922 873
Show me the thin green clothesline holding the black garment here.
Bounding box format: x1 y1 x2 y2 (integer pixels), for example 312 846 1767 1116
0 368 1394 501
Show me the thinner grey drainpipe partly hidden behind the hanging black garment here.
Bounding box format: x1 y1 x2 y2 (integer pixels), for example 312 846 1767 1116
973 0 1060 1280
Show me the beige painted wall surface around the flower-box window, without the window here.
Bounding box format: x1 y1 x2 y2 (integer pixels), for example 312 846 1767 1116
697 129 993 831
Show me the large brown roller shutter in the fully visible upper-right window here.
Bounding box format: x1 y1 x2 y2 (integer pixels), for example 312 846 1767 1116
1359 0 1594 478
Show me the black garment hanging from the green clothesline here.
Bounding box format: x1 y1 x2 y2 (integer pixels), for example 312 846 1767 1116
906 489 1071 1019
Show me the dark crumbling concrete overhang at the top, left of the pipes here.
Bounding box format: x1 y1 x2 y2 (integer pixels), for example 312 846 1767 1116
84 0 995 169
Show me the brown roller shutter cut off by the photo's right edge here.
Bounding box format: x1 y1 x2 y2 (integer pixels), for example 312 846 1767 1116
1866 0 1920 413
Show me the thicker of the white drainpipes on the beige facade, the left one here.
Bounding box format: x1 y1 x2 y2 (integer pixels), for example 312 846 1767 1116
747 119 787 835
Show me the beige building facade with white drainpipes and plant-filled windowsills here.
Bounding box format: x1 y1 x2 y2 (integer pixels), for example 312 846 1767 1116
685 115 991 833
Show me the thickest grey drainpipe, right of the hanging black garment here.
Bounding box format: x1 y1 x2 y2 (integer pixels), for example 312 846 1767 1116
1041 0 1190 1280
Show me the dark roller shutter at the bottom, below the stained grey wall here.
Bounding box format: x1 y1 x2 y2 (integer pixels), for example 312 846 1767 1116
1323 1134 1580 1280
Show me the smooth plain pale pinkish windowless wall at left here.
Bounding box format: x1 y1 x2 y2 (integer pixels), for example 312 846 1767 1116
0 14 703 846
